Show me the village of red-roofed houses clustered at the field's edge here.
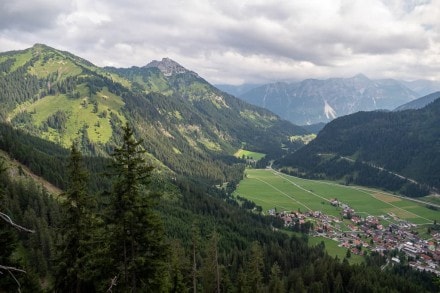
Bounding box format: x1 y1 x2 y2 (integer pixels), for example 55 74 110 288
268 198 440 276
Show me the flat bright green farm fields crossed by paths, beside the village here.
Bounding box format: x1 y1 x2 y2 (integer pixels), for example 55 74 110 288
235 169 440 225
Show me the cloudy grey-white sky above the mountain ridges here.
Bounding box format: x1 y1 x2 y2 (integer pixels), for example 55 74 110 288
0 0 440 85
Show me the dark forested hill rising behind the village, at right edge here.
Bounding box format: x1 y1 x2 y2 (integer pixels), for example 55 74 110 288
276 99 440 196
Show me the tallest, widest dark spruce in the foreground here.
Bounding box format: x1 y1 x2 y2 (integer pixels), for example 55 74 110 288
108 123 167 292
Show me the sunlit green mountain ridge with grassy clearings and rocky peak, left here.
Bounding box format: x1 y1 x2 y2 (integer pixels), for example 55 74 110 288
0 44 305 182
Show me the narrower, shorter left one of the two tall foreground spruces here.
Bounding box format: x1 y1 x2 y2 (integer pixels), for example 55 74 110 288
55 144 91 292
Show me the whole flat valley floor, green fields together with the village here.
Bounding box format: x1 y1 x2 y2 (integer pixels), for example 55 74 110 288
236 169 440 274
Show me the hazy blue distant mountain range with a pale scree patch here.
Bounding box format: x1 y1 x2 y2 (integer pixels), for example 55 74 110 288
239 74 418 125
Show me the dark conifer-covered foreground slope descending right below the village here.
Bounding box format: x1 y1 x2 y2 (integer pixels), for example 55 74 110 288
0 131 438 292
